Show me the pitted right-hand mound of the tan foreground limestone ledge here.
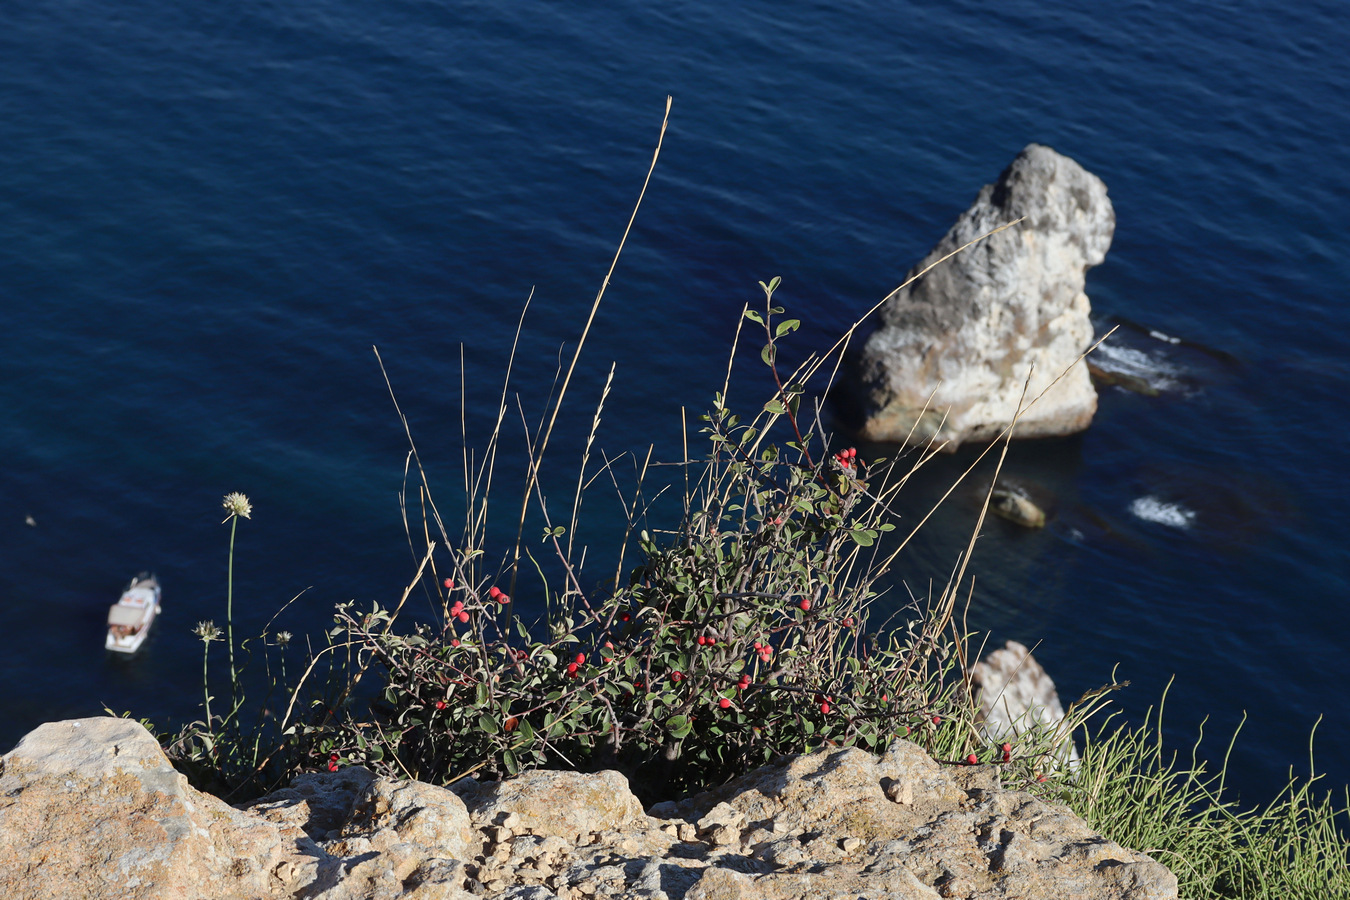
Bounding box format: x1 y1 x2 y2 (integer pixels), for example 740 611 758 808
652 741 1177 900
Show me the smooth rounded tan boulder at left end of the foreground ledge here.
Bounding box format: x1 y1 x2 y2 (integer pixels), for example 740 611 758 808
0 716 321 900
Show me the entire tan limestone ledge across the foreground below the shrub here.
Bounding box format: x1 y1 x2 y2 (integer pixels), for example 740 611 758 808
0 718 1176 900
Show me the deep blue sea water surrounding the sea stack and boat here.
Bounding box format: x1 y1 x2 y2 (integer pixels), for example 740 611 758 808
0 0 1350 799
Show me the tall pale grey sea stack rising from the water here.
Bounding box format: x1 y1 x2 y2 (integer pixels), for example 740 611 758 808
855 144 1115 449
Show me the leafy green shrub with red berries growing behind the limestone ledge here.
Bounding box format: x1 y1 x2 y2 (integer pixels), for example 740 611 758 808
292 279 1052 796
